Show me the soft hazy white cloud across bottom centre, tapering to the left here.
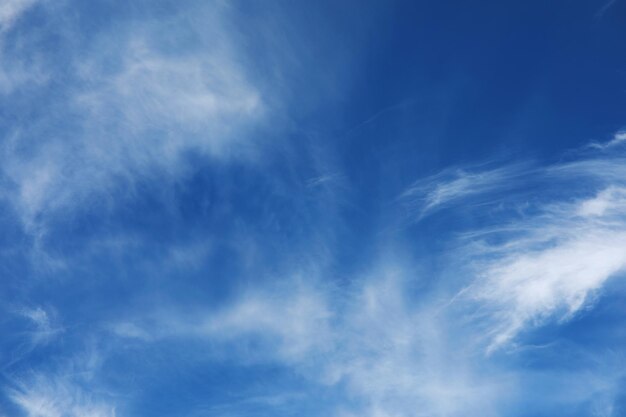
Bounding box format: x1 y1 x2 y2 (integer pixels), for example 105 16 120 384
107 267 512 417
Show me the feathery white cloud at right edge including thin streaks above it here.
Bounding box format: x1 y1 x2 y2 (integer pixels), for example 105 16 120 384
404 138 626 351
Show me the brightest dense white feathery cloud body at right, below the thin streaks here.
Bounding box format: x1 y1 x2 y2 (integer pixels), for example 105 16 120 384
470 188 626 348
